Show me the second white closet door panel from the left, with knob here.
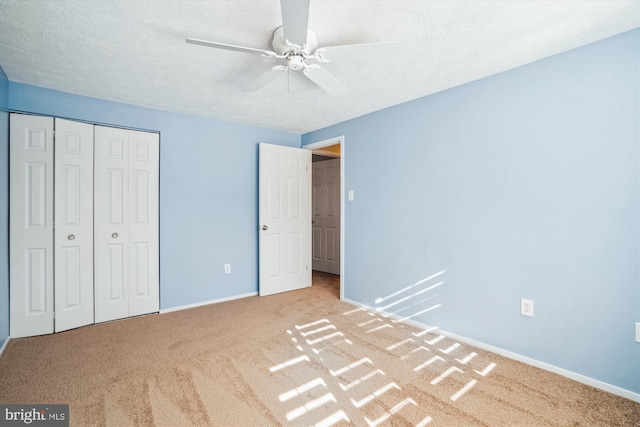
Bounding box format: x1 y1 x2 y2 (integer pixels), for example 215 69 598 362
54 119 93 332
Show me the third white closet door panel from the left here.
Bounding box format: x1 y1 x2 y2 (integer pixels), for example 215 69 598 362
94 126 129 322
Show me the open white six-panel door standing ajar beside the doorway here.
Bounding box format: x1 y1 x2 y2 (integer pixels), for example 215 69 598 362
259 144 311 296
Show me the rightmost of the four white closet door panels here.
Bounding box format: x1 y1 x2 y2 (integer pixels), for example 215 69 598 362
129 131 160 316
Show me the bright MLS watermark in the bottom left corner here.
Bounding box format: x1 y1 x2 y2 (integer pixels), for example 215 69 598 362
0 404 69 427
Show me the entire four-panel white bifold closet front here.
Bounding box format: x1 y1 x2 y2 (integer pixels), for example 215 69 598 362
9 114 159 338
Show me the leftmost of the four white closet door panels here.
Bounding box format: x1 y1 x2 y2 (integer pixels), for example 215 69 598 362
9 114 54 338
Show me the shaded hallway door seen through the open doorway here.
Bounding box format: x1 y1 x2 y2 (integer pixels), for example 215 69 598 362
312 158 340 274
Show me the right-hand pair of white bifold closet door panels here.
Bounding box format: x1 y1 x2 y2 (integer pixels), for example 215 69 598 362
94 126 159 322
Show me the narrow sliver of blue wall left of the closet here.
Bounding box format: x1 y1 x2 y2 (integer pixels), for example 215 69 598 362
0 67 9 348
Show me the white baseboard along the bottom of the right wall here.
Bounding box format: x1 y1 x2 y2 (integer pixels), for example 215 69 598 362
343 298 640 403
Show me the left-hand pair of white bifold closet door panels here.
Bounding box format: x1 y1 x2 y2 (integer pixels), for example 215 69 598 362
9 114 93 338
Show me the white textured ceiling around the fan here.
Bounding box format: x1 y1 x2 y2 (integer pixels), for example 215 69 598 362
0 0 640 133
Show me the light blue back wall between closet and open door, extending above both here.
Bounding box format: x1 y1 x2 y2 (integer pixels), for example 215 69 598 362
8 82 300 309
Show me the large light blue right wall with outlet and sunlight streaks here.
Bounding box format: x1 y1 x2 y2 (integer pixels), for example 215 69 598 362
302 30 640 393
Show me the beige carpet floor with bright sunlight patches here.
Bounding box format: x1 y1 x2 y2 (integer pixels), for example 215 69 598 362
0 274 640 426
